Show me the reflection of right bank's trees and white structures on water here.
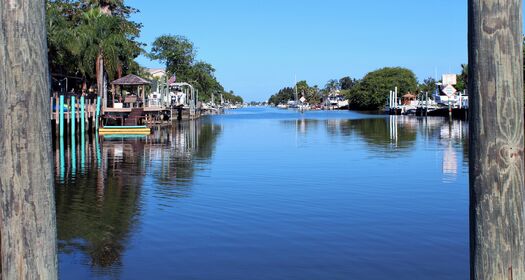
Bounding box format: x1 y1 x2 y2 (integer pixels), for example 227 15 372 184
281 116 468 177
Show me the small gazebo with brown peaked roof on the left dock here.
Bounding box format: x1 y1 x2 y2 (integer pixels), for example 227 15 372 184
111 74 151 108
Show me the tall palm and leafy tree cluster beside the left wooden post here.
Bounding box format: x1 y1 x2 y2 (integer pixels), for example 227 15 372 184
46 0 142 90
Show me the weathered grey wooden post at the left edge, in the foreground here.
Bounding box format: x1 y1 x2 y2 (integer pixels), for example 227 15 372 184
0 0 57 280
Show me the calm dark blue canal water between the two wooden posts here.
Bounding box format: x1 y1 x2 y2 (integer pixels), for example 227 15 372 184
55 108 469 280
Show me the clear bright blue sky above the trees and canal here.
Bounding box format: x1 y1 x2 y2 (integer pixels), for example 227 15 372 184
126 0 467 101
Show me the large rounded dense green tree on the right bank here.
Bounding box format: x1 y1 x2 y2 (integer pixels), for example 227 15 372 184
348 67 417 110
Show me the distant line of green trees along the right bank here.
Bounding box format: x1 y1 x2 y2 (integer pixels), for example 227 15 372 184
268 65 468 110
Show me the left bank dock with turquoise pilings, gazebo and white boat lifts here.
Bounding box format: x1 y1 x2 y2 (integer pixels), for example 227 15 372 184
49 75 216 137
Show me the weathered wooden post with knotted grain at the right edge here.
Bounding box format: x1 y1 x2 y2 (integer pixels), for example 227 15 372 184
468 0 525 280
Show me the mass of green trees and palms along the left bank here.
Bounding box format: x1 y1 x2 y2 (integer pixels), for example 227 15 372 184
46 0 243 103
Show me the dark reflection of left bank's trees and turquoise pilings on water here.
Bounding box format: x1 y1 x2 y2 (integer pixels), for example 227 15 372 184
55 122 221 277
